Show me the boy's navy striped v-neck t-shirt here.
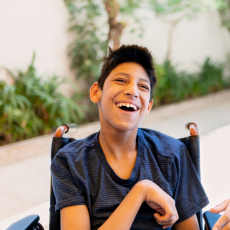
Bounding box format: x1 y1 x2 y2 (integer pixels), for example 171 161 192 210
51 129 208 230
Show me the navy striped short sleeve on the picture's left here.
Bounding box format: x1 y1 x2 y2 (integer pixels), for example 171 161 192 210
51 152 86 211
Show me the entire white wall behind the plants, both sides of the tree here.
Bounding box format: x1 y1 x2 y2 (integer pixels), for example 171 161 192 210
0 0 230 83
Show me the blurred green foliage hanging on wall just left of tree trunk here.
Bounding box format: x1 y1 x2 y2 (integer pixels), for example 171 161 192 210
64 0 107 84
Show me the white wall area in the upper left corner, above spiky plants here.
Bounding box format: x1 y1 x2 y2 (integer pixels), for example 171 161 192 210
0 0 73 83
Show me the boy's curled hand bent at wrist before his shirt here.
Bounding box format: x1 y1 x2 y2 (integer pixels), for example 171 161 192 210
139 180 179 229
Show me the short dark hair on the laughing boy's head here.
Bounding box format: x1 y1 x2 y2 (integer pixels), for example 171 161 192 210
97 45 157 101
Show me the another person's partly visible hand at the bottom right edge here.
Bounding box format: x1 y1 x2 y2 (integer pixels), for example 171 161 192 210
210 199 230 230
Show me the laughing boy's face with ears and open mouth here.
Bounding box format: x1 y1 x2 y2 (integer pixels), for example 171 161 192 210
90 62 153 131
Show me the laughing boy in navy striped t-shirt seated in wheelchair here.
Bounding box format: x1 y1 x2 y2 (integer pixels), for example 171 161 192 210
51 45 208 230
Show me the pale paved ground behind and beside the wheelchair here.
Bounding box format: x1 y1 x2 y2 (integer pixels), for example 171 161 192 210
0 91 230 229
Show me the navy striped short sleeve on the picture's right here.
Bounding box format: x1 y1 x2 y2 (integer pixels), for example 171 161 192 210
172 145 209 222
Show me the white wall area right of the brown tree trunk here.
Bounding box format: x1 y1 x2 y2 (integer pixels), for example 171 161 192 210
122 8 230 71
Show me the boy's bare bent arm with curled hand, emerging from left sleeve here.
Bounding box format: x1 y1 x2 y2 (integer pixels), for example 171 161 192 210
61 180 178 230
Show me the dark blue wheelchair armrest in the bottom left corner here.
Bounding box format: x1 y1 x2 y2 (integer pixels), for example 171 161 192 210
6 215 44 230
